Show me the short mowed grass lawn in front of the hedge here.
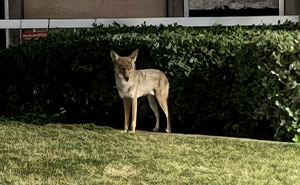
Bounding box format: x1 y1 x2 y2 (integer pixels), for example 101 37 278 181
0 121 300 185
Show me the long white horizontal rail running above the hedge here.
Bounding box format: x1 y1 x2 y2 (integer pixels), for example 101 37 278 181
0 16 299 29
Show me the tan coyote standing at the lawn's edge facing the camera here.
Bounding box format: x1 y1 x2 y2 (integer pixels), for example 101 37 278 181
110 49 171 133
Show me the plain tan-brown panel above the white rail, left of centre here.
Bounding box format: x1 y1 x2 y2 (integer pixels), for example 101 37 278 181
24 0 167 18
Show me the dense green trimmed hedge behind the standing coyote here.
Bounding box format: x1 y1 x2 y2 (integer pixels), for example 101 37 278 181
0 23 300 142
